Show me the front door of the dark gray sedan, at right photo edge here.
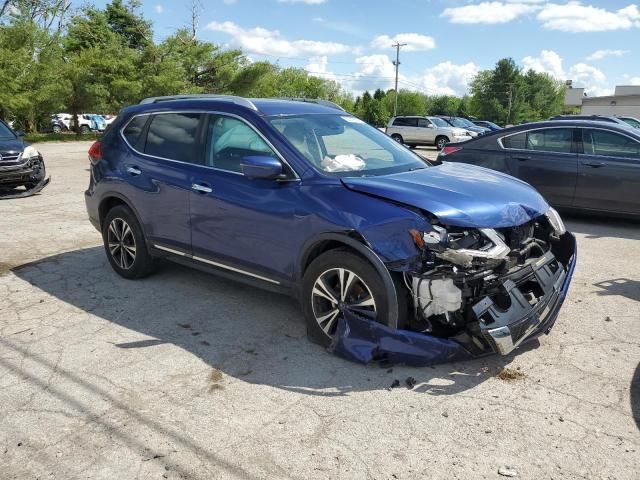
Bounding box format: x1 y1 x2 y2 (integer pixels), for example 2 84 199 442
574 128 640 214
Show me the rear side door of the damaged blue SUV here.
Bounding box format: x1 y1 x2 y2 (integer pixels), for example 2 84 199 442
120 113 203 254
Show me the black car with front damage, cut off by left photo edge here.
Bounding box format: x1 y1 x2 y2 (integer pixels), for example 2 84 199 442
0 120 46 190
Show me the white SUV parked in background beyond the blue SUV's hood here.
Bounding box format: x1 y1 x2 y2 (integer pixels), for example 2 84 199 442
385 116 471 150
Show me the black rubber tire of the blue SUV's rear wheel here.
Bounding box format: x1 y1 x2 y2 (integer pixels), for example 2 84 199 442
102 205 156 280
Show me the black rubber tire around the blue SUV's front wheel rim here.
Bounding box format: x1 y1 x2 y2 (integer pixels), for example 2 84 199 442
301 249 396 347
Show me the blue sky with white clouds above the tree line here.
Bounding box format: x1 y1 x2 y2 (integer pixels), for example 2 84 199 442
97 0 640 96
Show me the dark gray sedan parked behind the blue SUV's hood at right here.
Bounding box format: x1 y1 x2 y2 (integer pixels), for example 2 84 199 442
439 120 640 216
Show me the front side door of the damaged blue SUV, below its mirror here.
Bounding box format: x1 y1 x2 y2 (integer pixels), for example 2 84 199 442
190 114 300 282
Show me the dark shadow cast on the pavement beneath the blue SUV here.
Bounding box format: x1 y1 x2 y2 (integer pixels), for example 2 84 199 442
13 247 539 396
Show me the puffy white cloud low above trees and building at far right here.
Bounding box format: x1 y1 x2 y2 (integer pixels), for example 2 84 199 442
522 50 613 96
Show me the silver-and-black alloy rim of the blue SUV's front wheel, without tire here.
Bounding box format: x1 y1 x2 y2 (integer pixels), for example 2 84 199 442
311 268 377 336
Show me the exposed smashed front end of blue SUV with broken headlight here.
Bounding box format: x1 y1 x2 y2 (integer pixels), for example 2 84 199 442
403 209 574 355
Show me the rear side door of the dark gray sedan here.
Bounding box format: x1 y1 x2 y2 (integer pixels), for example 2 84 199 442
501 127 578 207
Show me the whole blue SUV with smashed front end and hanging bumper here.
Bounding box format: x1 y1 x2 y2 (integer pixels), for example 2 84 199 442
85 95 575 361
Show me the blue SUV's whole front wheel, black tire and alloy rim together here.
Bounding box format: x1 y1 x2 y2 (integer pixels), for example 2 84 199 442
302 249 389 347
